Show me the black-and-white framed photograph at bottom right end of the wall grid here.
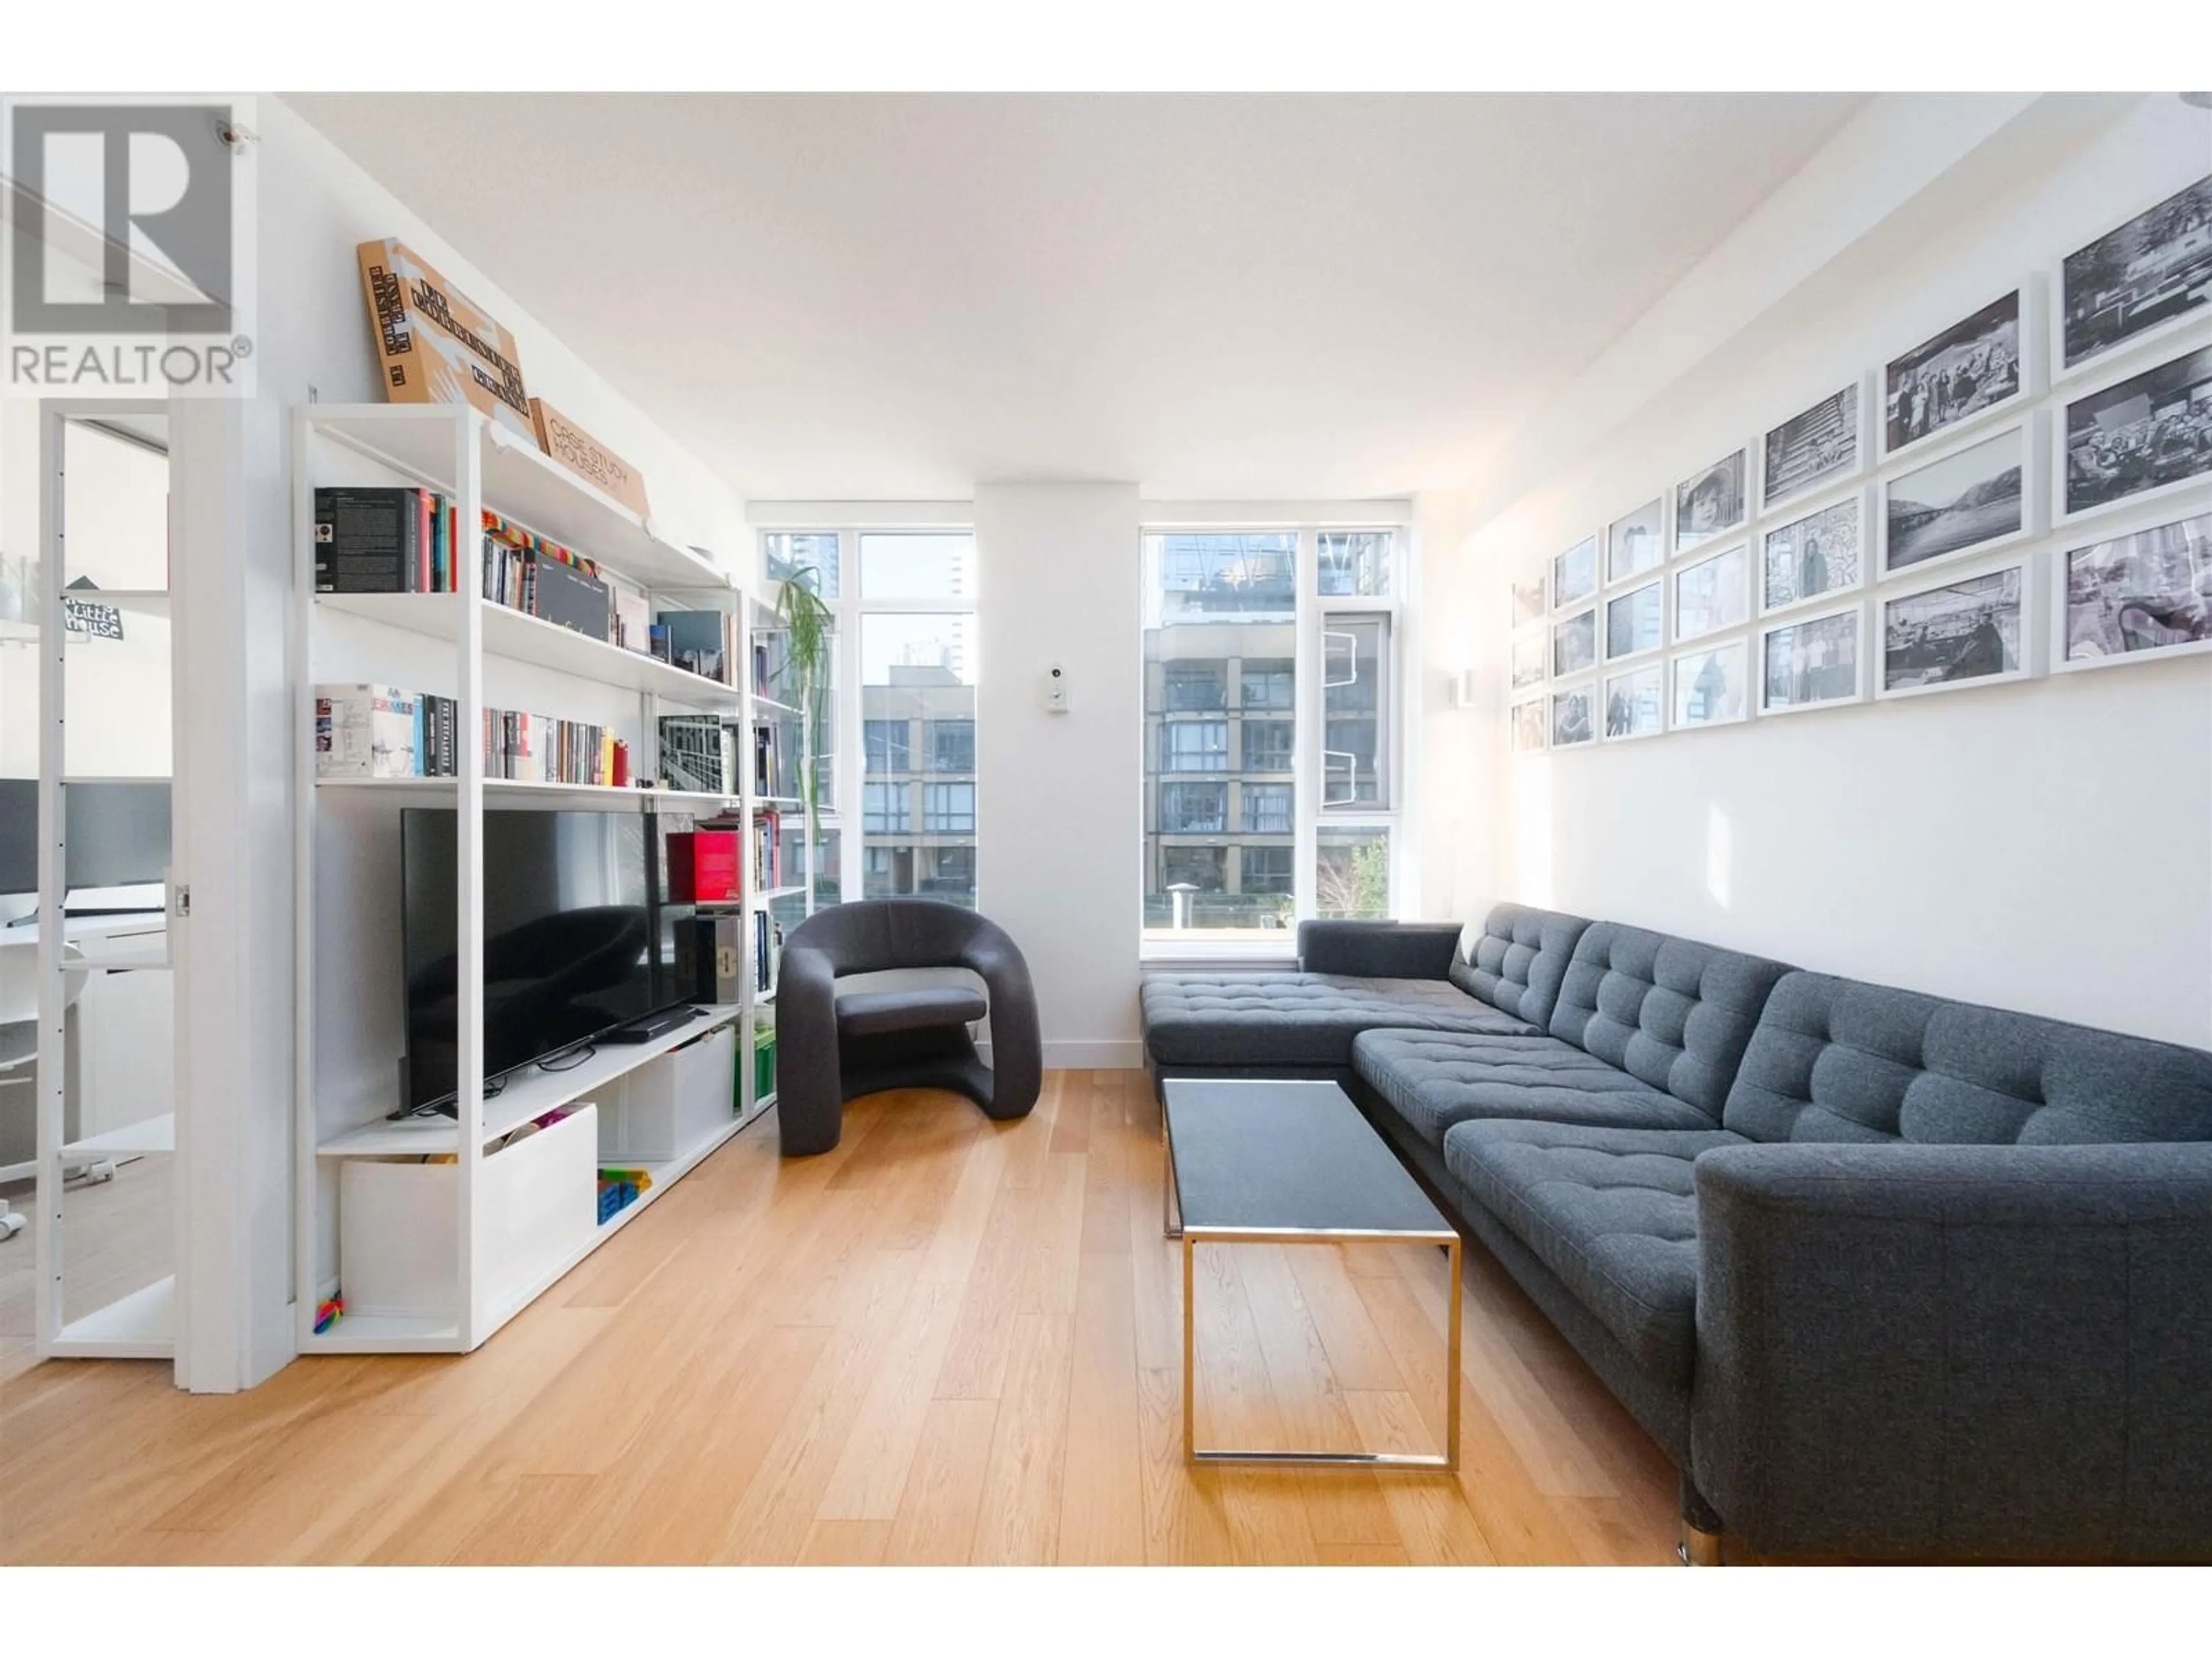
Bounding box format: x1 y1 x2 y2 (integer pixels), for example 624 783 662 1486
2059 513 2212 668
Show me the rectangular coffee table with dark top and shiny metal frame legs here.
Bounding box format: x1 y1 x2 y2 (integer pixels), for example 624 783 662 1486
1161 1077 1460 1469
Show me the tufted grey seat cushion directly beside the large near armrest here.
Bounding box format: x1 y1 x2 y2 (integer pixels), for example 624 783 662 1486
1445 1124 1743 1387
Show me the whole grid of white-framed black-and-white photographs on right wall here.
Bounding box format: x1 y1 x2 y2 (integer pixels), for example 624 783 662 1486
1513 173 2212 750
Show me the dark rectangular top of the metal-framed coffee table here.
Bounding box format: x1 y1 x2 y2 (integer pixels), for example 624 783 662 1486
1166 1077 1456 1243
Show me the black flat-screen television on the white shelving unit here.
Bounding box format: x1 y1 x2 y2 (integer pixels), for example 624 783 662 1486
400 808 690 1113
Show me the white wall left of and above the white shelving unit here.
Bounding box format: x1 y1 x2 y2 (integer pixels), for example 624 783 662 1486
199 97 748 1387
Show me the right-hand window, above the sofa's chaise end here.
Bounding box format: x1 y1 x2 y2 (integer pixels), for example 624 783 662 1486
1143 527 1404 938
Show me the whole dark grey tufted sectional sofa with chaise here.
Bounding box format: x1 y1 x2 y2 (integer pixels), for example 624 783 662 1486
1143 905 2212 1559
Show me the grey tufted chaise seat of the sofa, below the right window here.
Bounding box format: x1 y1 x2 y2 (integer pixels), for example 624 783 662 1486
1139 974 1535 1071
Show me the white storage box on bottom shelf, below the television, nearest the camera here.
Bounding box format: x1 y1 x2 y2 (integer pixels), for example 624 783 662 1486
339 1106 600 1319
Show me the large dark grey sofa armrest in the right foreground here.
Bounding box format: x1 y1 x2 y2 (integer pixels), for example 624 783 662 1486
1690 1143 2212 1559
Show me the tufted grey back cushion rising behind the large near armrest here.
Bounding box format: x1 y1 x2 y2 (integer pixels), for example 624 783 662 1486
1725 974 2212 1146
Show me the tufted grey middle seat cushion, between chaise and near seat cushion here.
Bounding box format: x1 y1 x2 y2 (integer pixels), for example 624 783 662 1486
1351 1031 1719 1146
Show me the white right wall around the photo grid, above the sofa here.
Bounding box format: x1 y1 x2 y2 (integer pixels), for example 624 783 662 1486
1431 97 2212 1046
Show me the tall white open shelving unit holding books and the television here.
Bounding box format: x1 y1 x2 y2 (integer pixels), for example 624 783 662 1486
292 405 777 1354
